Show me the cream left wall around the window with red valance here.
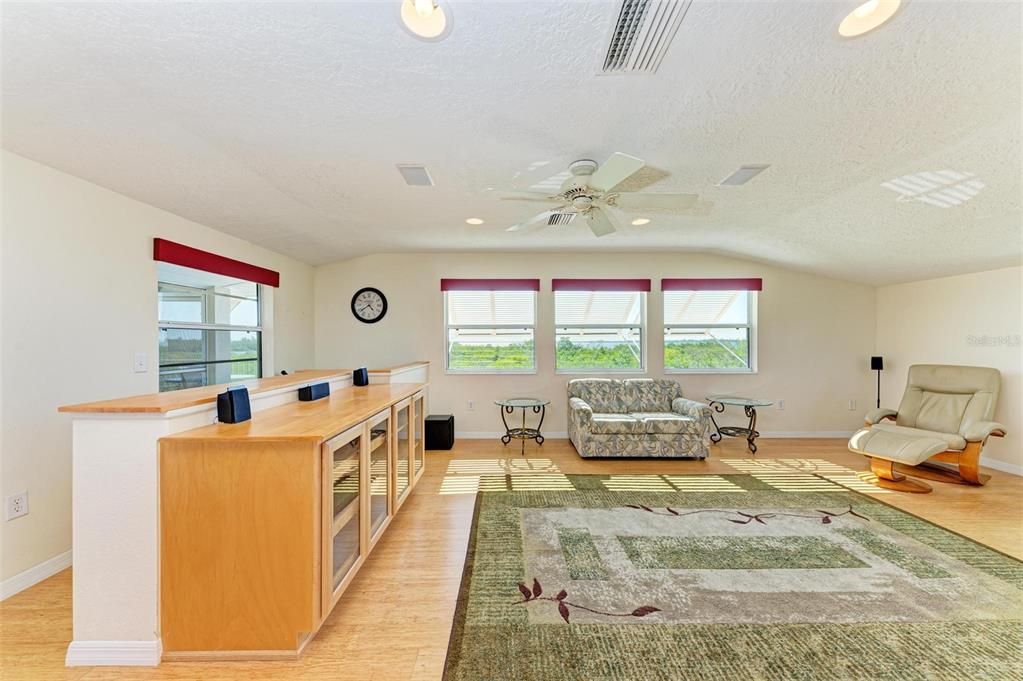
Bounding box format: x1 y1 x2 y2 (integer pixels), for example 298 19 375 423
0 151 313 580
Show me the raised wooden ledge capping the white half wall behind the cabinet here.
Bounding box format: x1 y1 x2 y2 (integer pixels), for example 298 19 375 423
57 362 430 414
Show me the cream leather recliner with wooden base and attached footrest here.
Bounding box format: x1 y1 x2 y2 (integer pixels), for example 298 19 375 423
849 364 1006 492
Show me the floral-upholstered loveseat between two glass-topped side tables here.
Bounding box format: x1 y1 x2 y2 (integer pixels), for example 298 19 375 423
568 378 713 459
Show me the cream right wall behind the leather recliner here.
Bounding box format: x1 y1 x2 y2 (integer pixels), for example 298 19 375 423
877 267 1023 474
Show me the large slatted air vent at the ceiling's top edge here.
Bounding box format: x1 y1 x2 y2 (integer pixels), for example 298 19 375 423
601 0 693 74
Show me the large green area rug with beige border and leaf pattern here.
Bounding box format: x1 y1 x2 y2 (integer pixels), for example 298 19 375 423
445 475 1023 681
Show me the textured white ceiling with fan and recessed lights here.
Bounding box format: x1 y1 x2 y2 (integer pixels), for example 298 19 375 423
2 0 1021 283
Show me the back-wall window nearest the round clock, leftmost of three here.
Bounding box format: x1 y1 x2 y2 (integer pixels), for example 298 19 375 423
442 279 539 373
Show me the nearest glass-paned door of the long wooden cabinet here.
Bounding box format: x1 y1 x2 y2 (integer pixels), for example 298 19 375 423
324 428 362 592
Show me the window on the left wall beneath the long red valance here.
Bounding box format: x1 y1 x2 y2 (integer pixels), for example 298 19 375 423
157 263 263 392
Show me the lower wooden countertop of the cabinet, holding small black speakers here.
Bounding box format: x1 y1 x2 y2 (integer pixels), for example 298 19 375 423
161 383 427 442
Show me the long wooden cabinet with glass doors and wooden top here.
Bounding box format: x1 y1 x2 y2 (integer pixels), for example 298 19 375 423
160 383 426 660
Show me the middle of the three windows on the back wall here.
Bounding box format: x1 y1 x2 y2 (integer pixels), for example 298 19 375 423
553 279 650 373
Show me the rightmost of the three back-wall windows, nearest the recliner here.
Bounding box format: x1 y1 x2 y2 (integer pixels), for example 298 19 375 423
662 279 759 372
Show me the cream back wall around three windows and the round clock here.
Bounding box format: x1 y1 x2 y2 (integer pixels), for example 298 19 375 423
315 253 875 434
